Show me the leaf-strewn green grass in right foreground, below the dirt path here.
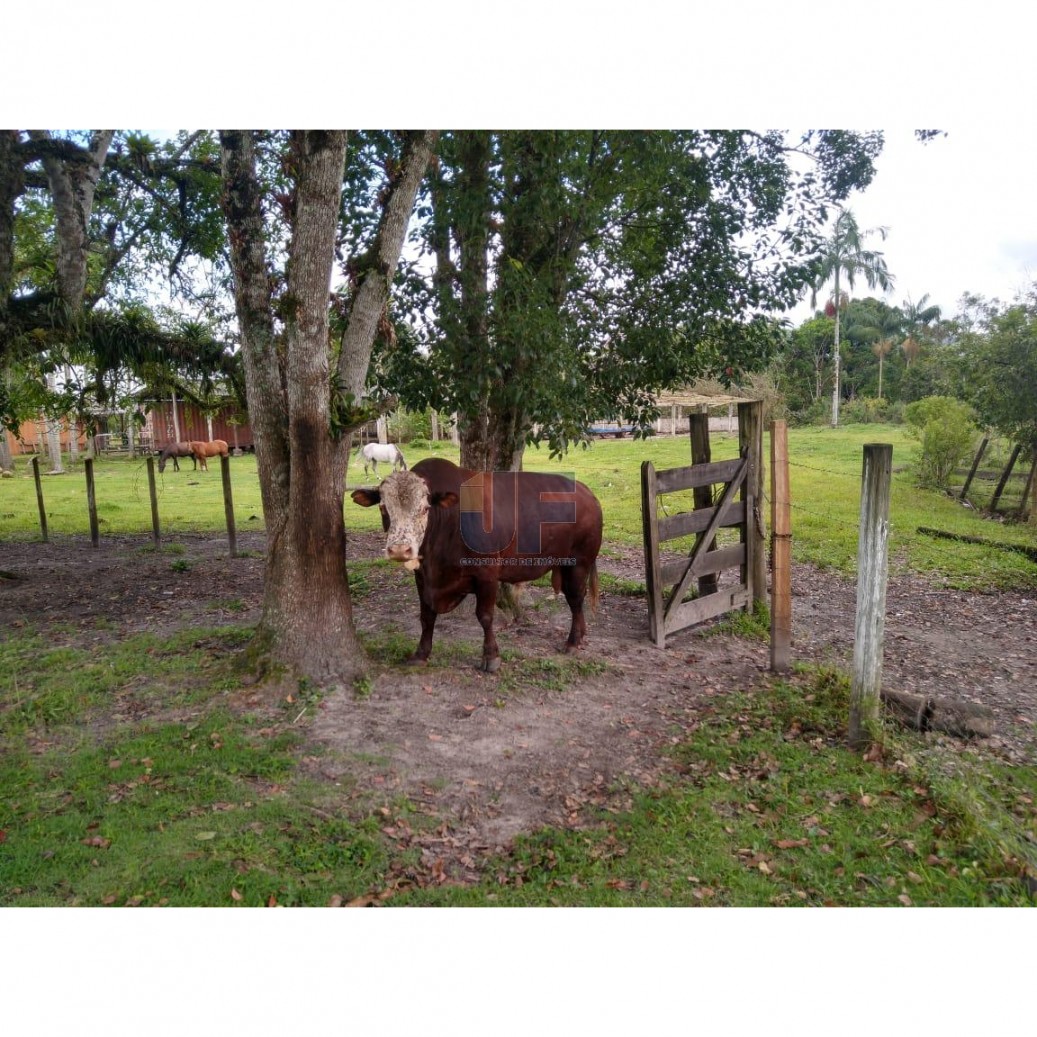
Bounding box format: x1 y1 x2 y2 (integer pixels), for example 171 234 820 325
389 672 1037 906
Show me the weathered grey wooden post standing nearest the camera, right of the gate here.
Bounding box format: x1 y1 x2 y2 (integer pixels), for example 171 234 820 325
849 443 893 749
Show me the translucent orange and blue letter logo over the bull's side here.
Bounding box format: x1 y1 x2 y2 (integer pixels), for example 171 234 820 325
460 472 577 555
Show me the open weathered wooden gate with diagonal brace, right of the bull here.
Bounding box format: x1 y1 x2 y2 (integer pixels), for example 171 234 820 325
641 452 757 648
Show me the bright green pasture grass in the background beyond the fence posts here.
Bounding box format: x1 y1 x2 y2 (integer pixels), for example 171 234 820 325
0 425 1037 592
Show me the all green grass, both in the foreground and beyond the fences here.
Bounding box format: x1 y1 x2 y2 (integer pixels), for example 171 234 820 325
0 425 1037 906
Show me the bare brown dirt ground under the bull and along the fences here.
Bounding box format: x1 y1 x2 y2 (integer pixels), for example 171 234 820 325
0 534 1037 878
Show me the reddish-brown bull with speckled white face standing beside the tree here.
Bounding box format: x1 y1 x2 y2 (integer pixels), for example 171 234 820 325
352 457 601 673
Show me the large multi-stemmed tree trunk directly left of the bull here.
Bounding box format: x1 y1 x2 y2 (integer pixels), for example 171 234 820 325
220 131 435 684
